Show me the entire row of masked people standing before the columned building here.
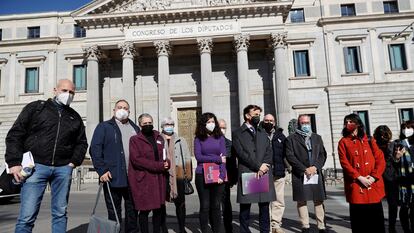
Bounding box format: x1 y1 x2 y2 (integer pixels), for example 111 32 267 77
5 79 414 233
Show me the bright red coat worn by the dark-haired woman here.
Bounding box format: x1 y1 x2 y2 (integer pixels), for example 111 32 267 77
338 135 385 204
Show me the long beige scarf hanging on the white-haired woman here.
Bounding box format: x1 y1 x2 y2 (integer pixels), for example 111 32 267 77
163 134 178 200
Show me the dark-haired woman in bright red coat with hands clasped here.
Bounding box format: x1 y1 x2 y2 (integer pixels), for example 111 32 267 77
338 114 385 233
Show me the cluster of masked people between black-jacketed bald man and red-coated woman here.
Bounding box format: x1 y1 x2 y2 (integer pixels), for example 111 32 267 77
90 103 326 233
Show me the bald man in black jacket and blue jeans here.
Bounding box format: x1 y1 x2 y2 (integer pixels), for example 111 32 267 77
5 79 88 233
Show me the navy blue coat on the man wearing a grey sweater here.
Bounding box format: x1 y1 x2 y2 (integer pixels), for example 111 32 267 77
89 118 140 188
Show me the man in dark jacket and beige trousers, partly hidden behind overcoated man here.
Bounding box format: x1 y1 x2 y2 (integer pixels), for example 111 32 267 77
262 114 286 233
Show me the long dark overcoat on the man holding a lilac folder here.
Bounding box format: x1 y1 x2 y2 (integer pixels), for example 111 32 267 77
232 124 276 204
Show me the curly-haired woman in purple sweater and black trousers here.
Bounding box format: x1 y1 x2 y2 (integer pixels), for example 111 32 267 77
194 112 226 233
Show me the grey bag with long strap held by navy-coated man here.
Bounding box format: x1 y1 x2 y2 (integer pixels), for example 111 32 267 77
87 183 121 233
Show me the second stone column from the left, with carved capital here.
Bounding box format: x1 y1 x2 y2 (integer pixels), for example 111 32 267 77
119 42 136 122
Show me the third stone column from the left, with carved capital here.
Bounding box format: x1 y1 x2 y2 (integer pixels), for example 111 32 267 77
154 40 171 125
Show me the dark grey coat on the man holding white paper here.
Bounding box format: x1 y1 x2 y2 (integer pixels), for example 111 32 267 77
285 133 326 202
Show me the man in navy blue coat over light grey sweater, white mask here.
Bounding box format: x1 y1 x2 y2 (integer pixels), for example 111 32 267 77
89 100 139 232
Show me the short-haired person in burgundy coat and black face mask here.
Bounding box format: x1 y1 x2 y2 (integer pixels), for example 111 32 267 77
128 113 169 233
